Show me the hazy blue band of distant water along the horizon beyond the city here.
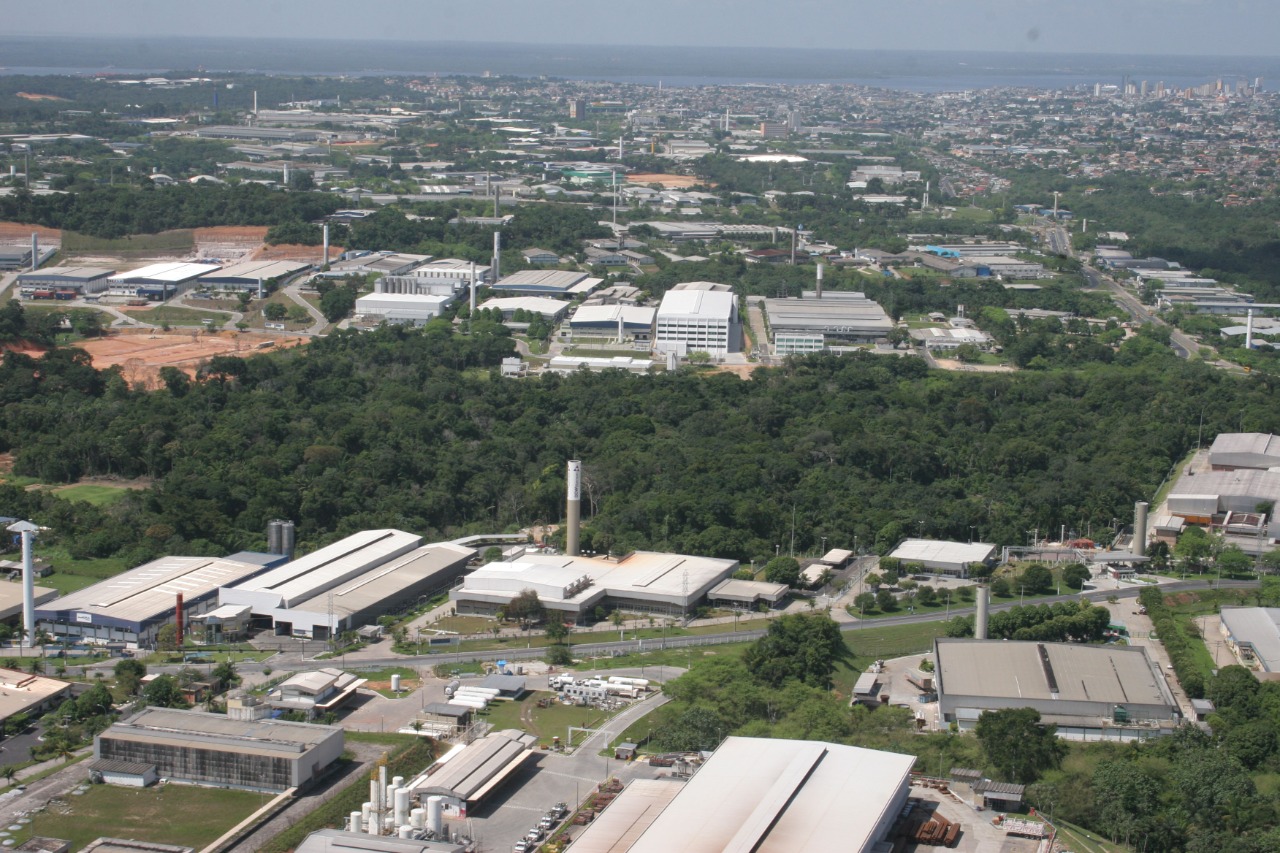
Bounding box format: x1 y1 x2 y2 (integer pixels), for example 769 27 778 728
0 36 1280 92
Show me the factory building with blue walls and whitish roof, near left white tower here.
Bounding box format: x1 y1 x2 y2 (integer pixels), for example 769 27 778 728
36 551 284 648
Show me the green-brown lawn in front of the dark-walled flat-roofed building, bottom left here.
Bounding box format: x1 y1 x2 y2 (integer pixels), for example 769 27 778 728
14 785 264 849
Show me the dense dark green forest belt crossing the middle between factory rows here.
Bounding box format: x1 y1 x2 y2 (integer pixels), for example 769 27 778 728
0 306 1280 561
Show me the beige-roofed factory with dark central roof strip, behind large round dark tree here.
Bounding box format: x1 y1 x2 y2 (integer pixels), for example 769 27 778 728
933 638 1181 740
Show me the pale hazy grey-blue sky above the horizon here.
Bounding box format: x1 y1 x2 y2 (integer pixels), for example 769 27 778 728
10 0 1280 56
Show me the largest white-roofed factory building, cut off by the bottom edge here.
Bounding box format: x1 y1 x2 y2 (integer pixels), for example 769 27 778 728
570 738 915 853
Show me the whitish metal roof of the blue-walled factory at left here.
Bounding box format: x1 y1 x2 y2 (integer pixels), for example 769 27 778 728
36 555 277 626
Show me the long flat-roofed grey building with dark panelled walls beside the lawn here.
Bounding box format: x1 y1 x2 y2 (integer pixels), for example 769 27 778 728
93 708 344 792
